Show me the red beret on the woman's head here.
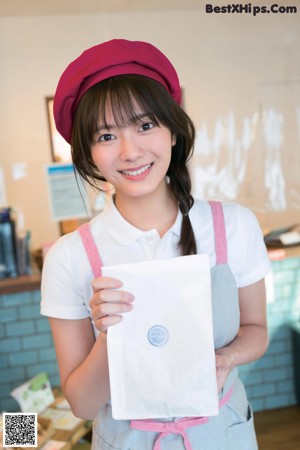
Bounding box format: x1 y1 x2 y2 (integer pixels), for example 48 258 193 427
54 39 181 143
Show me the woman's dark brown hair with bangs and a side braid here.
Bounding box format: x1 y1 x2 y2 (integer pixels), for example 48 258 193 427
71 75 197 255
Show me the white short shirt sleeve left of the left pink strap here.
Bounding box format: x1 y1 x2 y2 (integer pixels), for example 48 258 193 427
41 236 89 319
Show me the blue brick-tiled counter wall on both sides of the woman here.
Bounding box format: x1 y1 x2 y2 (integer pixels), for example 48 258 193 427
0 258 300 411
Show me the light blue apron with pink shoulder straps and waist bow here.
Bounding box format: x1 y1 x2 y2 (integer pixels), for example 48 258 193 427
80 202 258 450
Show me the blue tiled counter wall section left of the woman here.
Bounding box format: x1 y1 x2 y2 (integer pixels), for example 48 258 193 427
0 291 59 412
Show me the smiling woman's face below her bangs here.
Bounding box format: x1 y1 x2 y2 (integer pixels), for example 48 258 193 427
91 103 176 201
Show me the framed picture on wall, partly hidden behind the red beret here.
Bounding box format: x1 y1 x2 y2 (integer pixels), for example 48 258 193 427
46 97 71 163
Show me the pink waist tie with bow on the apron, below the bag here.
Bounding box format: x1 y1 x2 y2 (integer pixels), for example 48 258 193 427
130 386 234 450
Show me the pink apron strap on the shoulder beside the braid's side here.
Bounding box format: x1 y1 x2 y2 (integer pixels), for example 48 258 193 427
209 200 227 265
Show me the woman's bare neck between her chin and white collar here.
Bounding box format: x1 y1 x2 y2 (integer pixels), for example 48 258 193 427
115 186 178 237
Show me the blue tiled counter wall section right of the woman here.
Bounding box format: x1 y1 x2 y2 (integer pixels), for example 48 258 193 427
239 258 300 411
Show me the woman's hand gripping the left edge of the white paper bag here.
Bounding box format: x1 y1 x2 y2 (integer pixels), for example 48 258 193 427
89 277 134 332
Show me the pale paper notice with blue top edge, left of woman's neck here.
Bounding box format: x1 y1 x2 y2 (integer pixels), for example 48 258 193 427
46 164 89 221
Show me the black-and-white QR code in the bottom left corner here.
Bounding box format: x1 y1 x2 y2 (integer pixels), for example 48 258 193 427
3 413 37 447
